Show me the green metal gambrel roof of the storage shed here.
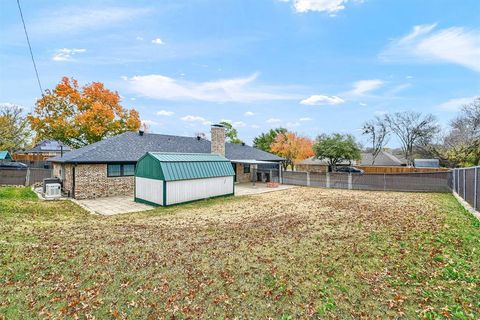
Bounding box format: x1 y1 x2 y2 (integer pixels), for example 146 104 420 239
135 152 235 181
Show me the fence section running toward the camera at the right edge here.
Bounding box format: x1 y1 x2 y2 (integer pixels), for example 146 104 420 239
453 167 480 210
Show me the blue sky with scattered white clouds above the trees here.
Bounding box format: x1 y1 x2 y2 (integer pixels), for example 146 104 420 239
0 0 480 146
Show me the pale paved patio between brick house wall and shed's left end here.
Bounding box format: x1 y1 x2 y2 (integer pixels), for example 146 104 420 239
74 196 155 216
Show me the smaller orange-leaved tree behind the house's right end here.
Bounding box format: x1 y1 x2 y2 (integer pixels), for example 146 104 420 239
270 131 314 170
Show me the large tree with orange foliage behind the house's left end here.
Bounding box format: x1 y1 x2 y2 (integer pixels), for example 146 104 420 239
28 77 141 148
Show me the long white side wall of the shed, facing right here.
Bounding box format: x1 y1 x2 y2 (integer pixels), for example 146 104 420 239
167 177 233 205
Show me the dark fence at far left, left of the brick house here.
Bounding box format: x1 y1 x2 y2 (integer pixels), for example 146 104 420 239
0 168 52 186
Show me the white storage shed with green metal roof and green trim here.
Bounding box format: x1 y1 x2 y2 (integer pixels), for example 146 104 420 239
135 152 235 206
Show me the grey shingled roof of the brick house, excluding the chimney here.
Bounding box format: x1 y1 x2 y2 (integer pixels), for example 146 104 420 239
49 132 283 163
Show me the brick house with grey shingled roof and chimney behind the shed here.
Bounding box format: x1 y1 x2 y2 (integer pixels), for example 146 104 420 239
50 125 283 199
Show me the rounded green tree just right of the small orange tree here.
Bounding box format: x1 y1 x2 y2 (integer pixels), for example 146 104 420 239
313 133 361 170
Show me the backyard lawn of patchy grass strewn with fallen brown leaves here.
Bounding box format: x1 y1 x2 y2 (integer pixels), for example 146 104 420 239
0 188 480 319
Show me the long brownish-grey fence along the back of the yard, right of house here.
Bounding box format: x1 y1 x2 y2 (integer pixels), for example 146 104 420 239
282 171 452 192
